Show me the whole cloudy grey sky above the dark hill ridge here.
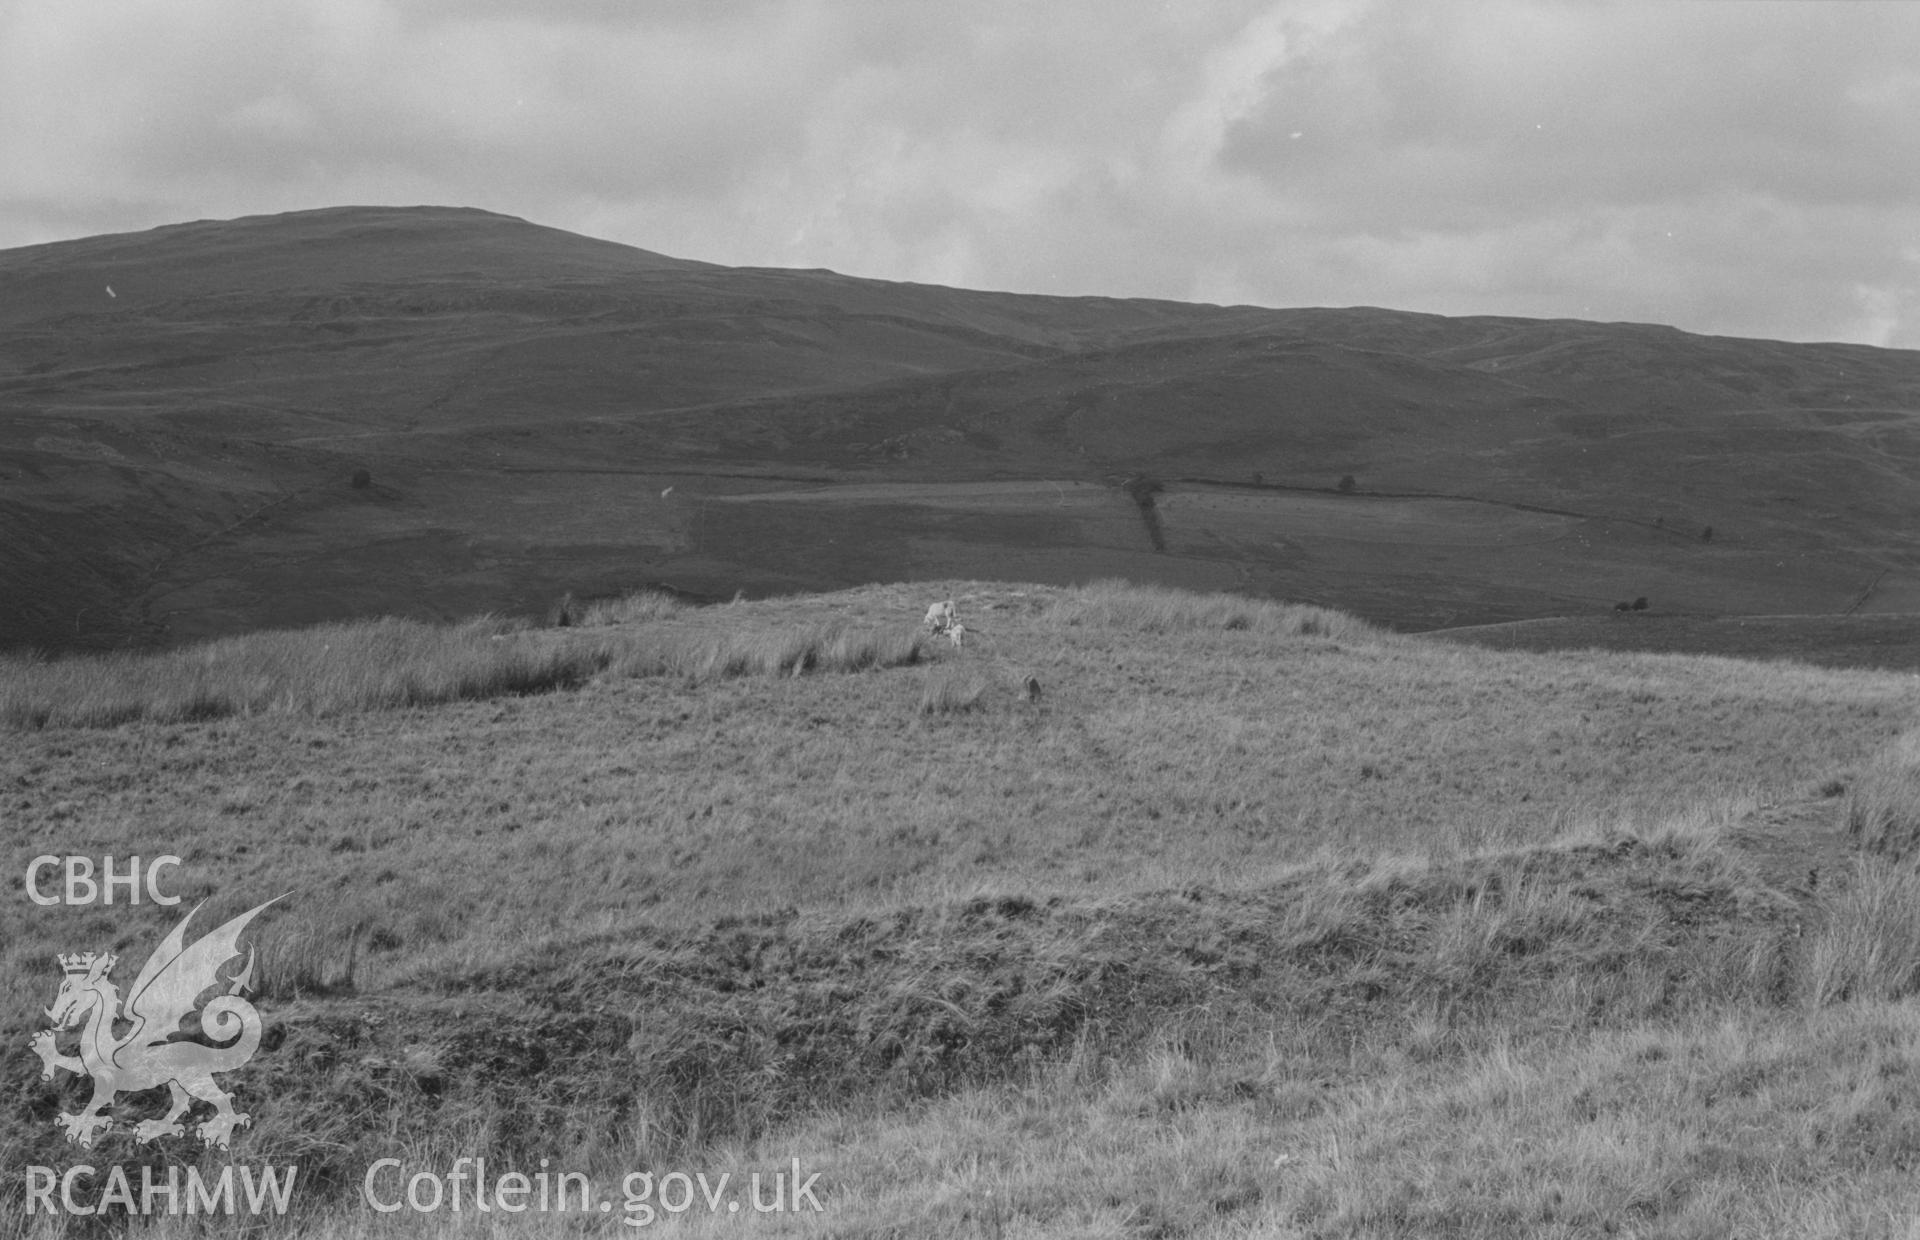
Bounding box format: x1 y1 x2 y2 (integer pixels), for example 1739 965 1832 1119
0 0 1920 347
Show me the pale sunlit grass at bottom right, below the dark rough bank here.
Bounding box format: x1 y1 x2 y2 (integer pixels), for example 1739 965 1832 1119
656 1006 1920 1240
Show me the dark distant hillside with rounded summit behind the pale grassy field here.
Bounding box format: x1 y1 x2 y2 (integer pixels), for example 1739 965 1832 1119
0 207 1920 649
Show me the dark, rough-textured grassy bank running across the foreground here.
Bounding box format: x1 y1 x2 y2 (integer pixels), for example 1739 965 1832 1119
3 817 1812 1230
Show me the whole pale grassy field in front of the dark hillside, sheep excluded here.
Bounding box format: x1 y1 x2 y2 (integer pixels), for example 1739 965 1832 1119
0 582 1920 1238
